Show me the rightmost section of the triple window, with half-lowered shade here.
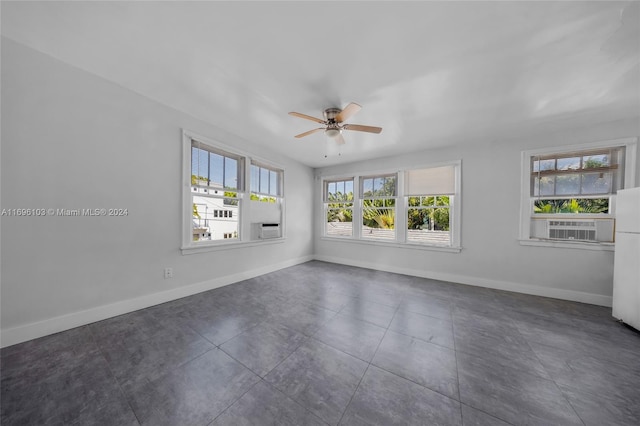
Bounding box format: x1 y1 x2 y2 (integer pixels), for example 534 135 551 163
405 165 455 246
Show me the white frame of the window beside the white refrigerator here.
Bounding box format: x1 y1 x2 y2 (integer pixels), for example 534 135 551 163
519 138 638 251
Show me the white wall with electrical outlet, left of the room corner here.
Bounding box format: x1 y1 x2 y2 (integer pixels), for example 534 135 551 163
0 38 313 346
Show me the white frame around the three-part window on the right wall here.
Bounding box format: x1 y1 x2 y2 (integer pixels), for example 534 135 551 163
319 160 462 253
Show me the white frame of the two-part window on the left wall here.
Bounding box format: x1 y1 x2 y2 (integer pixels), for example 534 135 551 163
181 129 286 251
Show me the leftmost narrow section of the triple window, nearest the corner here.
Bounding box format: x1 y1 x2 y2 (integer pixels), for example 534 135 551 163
323 178 353 237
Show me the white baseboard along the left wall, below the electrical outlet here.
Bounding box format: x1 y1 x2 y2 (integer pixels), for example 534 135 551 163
0 255 314 348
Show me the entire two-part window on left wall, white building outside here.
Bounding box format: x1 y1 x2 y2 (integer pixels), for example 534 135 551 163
182 131 284 253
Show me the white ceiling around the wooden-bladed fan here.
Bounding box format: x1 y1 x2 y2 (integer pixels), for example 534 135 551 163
1 1 640 167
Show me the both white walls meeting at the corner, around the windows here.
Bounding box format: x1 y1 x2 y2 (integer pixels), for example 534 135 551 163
0 38 640 346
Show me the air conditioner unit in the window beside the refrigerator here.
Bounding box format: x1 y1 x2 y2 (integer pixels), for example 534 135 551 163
532 218 614 242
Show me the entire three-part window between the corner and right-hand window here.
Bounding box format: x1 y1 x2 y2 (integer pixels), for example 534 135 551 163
322 161 461 251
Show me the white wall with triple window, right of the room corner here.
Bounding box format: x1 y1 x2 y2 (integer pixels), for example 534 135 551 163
315 118 640 306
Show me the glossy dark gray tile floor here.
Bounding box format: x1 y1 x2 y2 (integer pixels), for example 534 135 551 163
1 262 640 426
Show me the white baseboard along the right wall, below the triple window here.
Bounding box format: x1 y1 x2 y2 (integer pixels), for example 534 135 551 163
314 255 613 308
